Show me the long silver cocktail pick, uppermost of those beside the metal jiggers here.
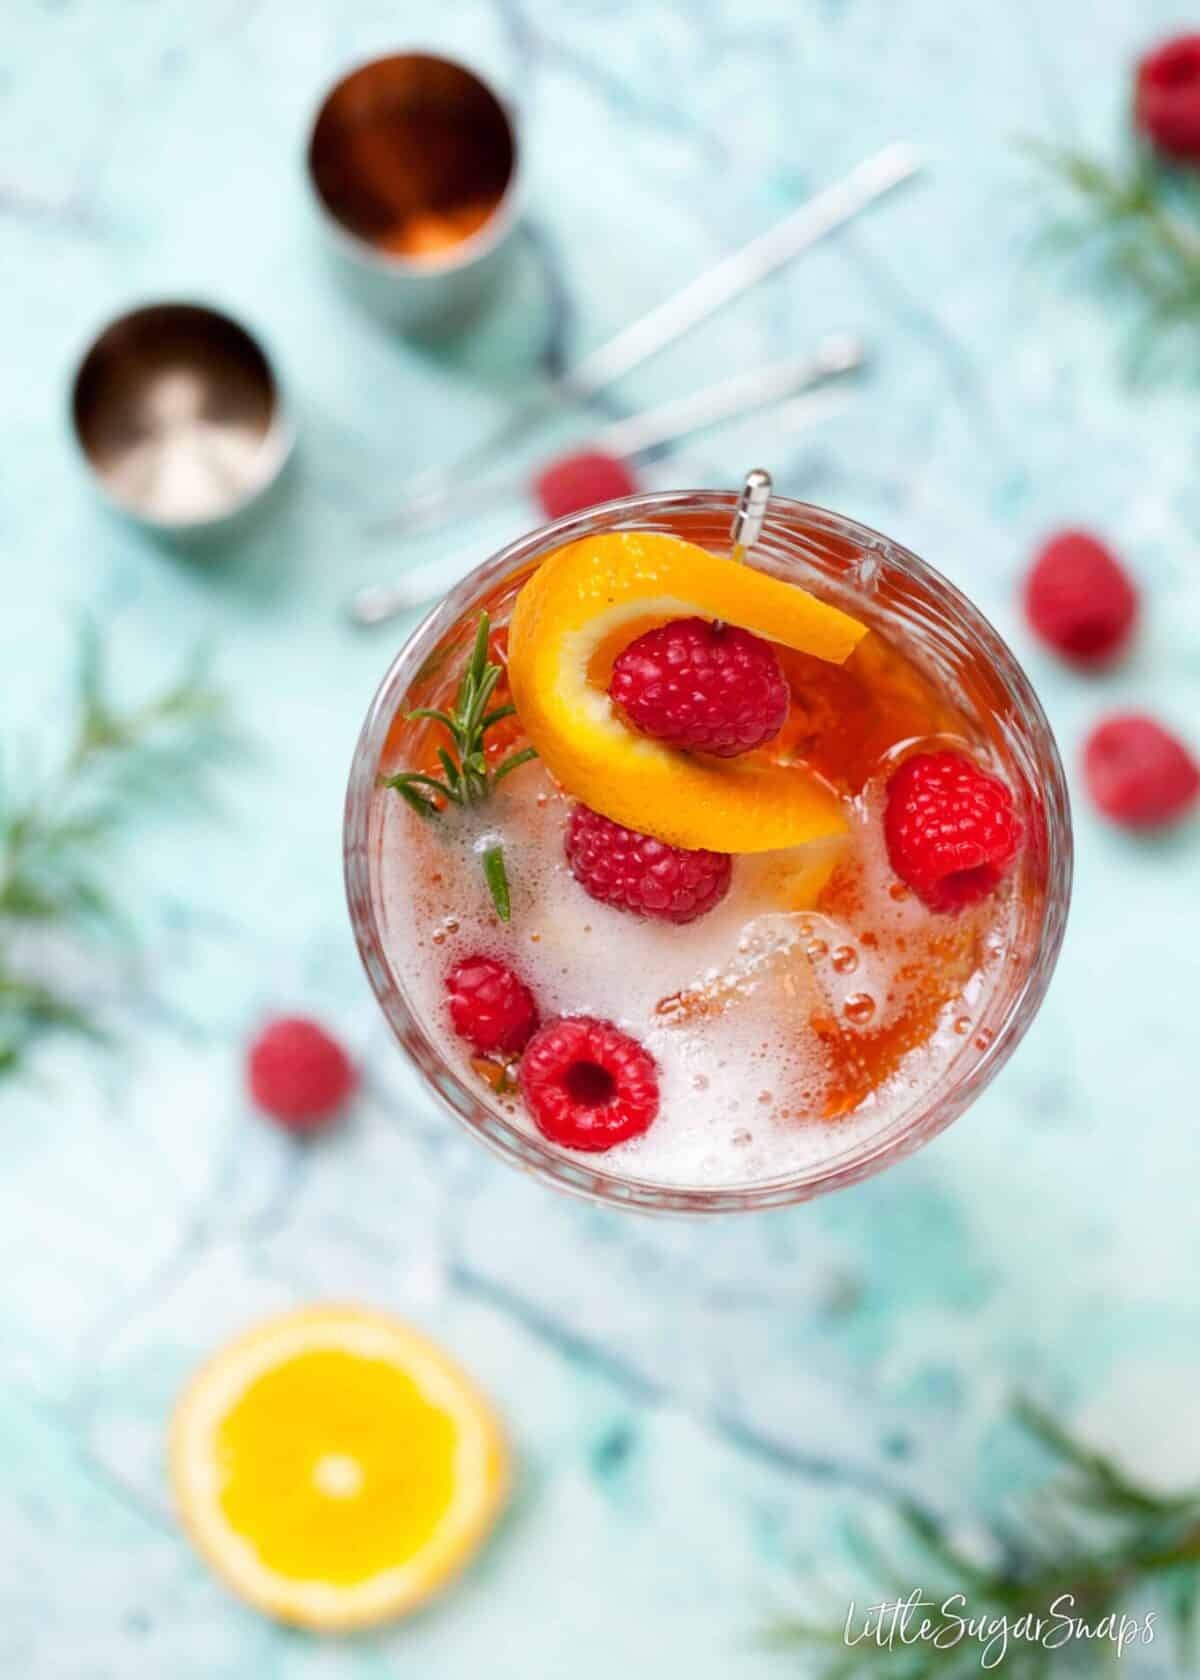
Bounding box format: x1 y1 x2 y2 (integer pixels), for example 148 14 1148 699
385 139 923 529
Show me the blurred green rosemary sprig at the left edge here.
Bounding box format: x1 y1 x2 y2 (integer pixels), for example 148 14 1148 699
0 623 229 1077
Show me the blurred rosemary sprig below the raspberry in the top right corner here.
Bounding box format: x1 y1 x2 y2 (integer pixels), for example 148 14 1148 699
1027 141 1200 375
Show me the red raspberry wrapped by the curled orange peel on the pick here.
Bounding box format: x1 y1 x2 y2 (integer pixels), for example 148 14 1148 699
608 618 788 758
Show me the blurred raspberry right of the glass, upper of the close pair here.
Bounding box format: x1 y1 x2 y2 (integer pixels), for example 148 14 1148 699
1025 531 1138 665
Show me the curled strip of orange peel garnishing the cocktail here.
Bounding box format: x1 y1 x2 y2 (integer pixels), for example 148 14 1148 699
508 531 867 852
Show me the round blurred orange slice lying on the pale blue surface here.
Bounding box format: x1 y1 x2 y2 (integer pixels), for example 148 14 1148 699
170 1305 508 1633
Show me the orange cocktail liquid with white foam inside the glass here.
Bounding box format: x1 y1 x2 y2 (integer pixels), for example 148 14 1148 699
378 557 1037 1184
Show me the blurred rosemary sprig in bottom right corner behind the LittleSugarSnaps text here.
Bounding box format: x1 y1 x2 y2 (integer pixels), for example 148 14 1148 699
768 1401 1200 1680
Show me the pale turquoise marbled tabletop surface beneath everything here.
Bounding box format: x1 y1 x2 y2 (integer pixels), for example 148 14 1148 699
0 0 1200 1680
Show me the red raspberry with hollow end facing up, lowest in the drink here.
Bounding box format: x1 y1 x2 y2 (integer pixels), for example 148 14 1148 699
518 1015 659 1151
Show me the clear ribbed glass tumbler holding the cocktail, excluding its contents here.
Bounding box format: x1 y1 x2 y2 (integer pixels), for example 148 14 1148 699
345 491 1072 1213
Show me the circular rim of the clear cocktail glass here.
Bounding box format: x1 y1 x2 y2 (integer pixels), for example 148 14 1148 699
343 491 1074 1213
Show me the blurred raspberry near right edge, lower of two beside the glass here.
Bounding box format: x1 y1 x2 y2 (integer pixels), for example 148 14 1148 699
1084 712 1200 828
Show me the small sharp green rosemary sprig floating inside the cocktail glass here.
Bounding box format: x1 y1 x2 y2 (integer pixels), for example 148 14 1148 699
383 612 538 922
